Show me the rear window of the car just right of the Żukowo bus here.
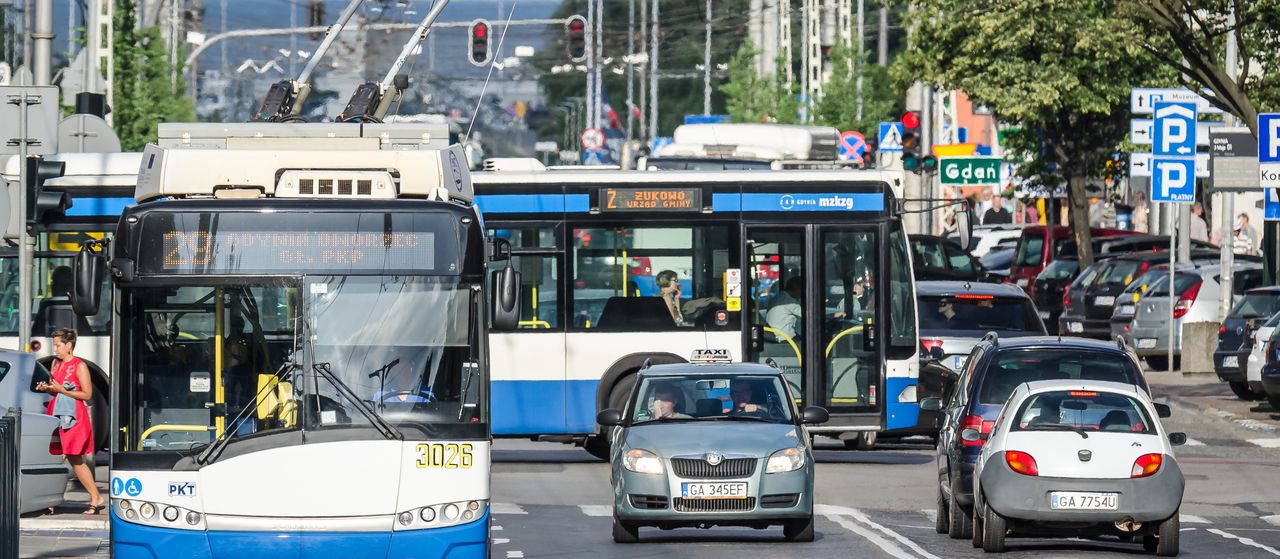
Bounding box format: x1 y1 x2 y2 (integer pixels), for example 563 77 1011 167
916 294 1041 331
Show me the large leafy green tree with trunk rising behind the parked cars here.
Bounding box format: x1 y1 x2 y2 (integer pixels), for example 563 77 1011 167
895 0 1169 266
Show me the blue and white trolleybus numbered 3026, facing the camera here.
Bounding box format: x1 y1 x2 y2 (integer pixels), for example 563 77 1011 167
74 123 518 559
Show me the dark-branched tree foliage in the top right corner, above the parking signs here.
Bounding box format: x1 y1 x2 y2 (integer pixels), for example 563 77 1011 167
1120 0 1280 136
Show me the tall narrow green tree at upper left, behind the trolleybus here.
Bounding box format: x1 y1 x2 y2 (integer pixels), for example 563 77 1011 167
111 0 196 151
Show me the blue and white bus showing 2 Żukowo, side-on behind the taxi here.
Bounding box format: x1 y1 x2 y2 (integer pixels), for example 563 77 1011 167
472 160 932 455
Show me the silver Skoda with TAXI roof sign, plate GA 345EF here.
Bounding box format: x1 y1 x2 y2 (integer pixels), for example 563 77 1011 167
596 363 828 544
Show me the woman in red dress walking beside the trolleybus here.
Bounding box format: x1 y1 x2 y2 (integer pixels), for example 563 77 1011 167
36 327 106 514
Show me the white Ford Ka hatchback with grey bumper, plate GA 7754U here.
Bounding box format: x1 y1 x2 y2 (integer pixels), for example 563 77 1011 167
973 380 1187 556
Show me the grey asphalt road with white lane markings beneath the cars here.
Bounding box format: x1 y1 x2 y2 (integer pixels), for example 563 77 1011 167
492 405 1280 559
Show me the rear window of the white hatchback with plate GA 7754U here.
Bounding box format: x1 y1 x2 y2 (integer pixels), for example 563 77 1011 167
1010 390 1156 435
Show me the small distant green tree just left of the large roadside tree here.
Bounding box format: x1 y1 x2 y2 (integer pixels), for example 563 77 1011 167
814 46 904 138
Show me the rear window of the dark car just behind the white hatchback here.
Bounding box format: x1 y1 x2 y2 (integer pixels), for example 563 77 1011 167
978 348 1142 404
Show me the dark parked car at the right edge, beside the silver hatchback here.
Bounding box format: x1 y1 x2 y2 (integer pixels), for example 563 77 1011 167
1213 285 1280 400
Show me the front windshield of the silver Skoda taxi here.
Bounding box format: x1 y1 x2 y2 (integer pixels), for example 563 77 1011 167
631 372 792 423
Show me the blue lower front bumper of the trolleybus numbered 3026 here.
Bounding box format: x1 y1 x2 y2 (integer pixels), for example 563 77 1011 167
111 510 489 559
